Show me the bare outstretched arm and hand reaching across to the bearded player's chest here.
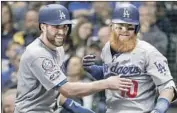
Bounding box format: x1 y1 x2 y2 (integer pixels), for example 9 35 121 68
59 76 132 97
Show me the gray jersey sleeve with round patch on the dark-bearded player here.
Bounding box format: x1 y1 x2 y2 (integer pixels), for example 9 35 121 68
30 57 67 90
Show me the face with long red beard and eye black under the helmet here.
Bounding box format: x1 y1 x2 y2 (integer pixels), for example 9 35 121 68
110 23 136 52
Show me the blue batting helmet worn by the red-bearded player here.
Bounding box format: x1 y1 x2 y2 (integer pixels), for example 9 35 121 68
112 3 140 33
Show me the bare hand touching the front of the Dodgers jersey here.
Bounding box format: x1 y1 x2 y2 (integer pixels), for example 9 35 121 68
106 76 133 91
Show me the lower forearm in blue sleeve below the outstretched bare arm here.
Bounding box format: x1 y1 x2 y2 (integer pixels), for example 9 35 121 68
59 95 94 113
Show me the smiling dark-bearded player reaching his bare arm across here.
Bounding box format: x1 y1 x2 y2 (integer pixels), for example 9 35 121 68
14 4 132 113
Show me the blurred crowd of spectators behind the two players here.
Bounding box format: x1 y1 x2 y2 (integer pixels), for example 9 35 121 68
1 1 177 113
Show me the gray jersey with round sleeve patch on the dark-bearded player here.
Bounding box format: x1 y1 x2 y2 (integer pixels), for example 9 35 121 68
14 38 67 113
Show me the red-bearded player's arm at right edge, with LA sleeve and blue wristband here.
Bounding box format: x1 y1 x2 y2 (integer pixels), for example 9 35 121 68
147 51 176 113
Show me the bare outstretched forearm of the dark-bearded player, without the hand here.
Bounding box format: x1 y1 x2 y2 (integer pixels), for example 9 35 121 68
60 80 109 97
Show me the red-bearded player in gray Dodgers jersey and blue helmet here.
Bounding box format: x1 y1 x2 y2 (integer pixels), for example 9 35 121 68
83 4 176 113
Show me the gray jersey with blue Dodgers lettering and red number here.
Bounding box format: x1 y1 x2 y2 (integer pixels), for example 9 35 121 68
101 40 175 113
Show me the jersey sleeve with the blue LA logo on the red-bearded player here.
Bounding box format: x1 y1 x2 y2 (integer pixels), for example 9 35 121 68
146 51 173 86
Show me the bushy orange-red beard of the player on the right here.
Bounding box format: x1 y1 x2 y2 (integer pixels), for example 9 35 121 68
110 32 137 53
